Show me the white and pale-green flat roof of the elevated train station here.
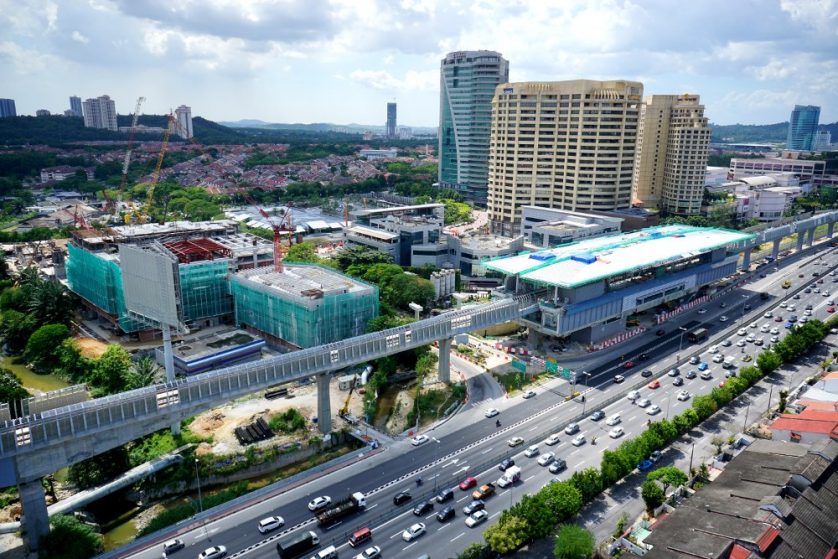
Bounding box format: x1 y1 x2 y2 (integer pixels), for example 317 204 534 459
484 225 755 288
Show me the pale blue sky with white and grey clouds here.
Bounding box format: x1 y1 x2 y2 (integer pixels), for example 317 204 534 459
0 0 838 126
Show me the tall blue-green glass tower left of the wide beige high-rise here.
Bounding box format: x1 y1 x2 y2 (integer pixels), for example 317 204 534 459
439 50 509 205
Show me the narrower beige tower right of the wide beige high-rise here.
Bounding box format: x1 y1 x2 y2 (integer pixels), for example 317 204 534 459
632 94 710 215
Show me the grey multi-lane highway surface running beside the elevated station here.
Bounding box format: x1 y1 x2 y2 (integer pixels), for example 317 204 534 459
122 244 838 559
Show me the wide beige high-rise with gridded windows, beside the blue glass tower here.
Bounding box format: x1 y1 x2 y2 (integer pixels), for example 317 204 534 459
488 80 643 236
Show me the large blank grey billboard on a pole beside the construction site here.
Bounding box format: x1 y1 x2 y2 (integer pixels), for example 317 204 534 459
119 245 180 326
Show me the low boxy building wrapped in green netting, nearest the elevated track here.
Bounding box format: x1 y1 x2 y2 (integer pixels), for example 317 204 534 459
230 265 378 347
